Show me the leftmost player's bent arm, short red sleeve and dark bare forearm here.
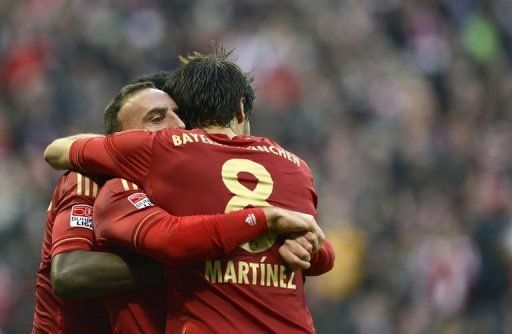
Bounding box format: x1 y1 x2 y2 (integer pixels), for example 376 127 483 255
51 173 162 296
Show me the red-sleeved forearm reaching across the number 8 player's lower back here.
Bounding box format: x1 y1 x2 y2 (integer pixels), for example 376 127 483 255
112 209 268 265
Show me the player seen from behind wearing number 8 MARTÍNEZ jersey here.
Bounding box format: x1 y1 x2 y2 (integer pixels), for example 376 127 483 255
45 51 334 333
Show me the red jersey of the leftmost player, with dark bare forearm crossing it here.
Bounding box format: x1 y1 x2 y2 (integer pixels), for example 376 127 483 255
33 172 110 334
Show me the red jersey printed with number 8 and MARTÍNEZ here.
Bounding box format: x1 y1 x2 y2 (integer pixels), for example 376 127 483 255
70 129 332 333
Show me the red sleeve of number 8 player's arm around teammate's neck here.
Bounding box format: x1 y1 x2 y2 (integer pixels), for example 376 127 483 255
69 130 155 183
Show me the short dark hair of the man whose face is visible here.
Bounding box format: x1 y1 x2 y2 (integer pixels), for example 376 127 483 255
103 81 155 134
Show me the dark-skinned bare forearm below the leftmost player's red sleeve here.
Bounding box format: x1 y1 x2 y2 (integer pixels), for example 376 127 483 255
51 250 163 297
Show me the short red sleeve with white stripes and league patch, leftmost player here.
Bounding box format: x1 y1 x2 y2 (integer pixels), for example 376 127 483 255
51 173 98 257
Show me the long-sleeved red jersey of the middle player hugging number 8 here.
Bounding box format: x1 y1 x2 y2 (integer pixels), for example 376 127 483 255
94 179 267 334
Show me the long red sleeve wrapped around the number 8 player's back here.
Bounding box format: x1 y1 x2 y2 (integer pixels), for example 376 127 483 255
94 179 268 265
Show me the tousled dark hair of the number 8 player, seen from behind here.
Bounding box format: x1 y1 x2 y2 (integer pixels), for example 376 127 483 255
164 47 254 128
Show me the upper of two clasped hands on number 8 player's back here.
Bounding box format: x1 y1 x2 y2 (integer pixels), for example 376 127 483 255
263 207 325 253
